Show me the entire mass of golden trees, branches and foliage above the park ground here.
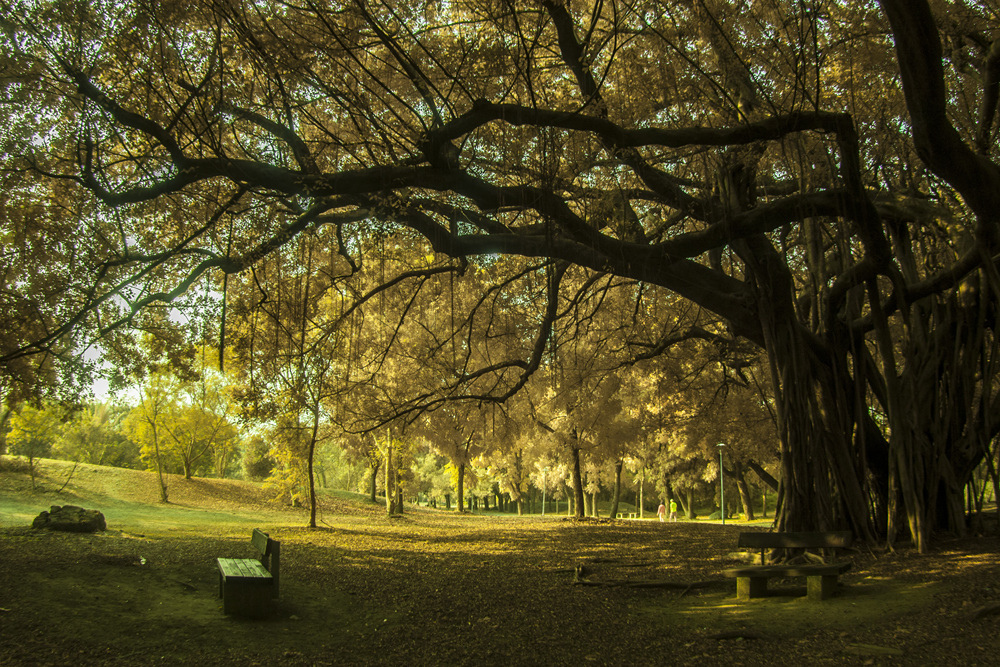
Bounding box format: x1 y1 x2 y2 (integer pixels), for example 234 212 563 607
0 0 1000 551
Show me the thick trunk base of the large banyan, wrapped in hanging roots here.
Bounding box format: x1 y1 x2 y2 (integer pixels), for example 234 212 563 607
742 235 998 552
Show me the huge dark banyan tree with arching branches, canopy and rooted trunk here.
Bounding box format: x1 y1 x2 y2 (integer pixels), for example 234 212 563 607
0 0 1000 548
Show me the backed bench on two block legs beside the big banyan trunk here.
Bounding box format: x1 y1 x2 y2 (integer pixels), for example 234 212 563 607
723 531 852 602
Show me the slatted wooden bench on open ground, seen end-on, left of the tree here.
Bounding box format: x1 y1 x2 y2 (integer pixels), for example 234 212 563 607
215 528 281 618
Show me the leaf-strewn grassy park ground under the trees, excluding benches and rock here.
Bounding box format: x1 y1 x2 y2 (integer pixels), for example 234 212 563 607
0 459 1000 666
